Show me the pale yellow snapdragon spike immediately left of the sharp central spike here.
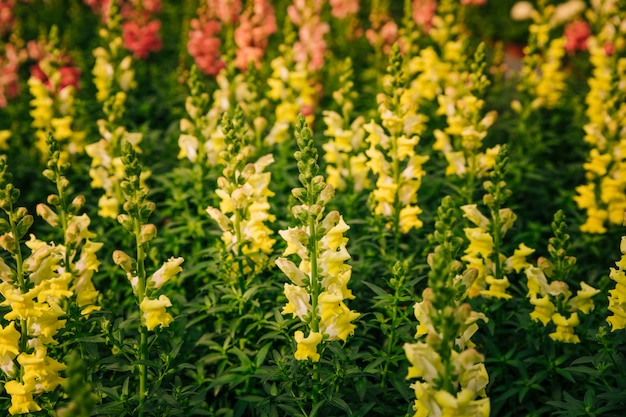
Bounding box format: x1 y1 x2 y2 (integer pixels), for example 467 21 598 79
206 109 275 273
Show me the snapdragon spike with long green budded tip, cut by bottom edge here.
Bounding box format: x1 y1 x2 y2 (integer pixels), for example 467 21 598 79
404 197 490 417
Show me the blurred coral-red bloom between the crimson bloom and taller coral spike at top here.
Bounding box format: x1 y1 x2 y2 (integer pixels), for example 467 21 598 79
187 19 226 76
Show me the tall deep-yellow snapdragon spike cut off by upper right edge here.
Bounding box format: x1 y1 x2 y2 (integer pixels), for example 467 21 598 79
574 6 626 233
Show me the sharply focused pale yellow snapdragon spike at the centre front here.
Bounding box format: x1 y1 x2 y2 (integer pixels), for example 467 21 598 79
276 115 359 362
